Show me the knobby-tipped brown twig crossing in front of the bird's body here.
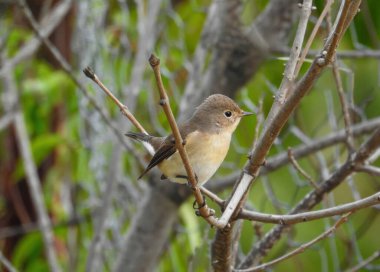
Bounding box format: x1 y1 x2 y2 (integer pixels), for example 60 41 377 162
149 54 225 228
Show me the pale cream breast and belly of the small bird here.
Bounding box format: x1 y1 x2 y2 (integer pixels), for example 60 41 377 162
158 131 232 185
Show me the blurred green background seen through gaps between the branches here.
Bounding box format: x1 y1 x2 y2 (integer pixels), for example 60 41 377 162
0 0 380 271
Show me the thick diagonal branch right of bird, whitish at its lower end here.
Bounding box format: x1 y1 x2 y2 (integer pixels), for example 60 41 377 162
220 0 360 230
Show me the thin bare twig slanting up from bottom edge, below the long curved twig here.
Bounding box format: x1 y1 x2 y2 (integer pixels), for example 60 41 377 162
233 212 352 272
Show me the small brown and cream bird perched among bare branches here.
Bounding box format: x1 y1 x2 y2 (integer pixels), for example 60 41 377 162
125 94 253 185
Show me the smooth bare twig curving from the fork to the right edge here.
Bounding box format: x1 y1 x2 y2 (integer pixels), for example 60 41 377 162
239 190 380 225
